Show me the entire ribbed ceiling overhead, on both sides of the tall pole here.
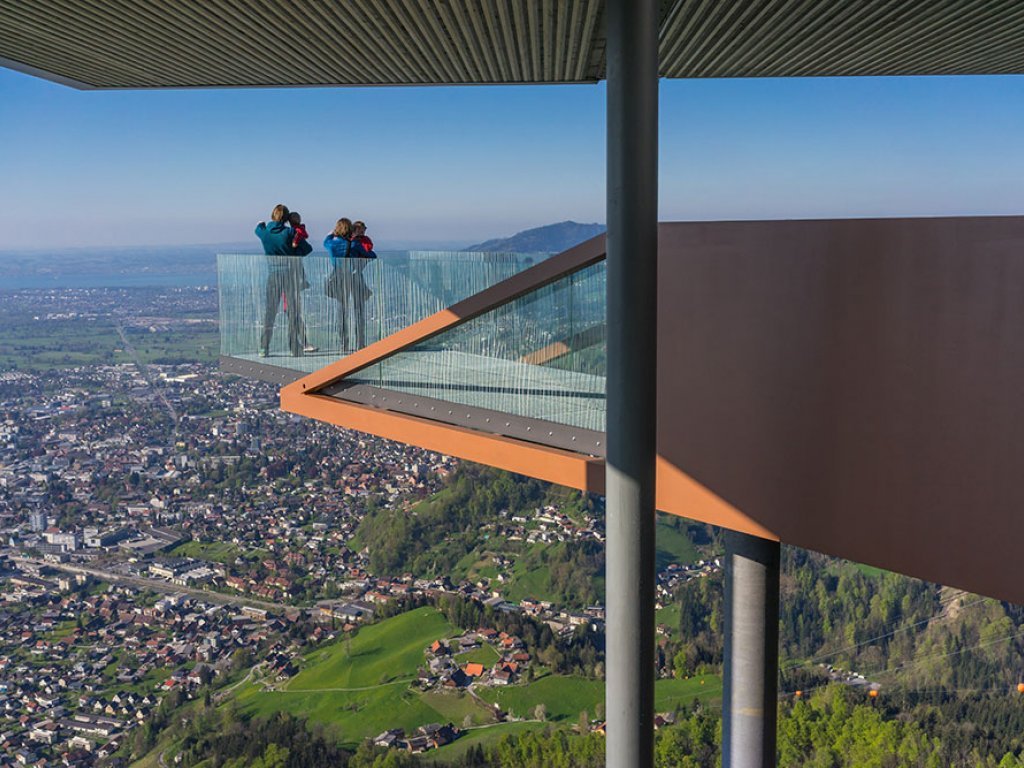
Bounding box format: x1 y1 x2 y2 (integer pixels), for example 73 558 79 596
0 0 1024 88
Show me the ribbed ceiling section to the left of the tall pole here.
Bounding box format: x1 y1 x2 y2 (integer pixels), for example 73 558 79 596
0 0 604 88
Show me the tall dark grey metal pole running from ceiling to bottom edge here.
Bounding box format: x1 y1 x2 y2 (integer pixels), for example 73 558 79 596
605 0 659 768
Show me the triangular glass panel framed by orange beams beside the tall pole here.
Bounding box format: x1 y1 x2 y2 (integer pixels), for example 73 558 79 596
347 262 606 432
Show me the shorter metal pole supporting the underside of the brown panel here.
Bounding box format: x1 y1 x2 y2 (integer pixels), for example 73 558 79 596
722 530 779 768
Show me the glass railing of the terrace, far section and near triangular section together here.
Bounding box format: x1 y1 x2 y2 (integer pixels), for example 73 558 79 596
218 247 606 438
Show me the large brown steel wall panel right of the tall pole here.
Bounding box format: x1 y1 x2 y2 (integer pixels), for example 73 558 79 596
657 218 1024 602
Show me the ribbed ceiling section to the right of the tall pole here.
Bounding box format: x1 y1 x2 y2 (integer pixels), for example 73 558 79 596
659 0 1024 78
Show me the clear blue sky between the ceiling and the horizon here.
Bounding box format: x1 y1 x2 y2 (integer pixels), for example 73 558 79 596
0 69 1024 249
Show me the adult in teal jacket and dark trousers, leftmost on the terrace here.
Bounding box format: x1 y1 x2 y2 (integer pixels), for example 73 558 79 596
256 204 312 357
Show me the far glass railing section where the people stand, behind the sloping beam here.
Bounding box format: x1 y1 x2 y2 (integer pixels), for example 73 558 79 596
217 251 549 373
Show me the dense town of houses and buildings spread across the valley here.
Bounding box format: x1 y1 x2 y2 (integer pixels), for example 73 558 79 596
0 289 718 766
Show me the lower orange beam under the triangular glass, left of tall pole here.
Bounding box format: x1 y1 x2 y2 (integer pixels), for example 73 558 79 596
281 387 604 494
